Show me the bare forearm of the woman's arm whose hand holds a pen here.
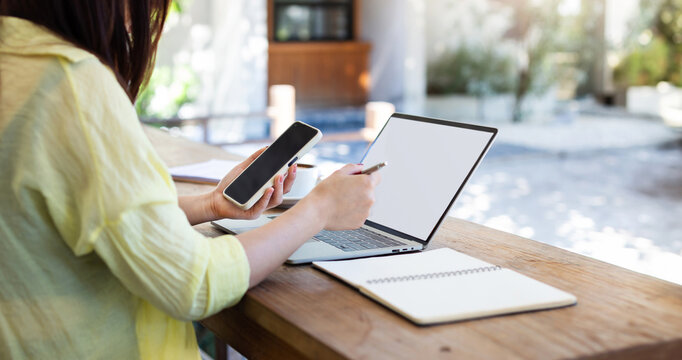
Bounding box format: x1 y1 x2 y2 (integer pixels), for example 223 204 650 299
237 196 327 287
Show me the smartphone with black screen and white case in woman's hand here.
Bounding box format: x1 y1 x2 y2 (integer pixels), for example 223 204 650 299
223 121 322 210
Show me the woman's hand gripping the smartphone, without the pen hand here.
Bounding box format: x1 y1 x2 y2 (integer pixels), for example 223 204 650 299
210 148 296 219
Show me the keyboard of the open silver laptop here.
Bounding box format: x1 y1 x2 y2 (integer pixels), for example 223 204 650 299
313 228 405 251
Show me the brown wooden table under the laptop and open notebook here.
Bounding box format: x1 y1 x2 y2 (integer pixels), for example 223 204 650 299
147 129 682 359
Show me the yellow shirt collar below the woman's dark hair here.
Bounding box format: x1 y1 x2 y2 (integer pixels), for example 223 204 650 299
0 16 94 62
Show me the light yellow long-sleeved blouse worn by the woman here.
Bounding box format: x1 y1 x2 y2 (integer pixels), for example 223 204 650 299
0 17 249 359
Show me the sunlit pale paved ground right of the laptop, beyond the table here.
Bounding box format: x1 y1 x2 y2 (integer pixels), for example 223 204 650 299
451 139 682 284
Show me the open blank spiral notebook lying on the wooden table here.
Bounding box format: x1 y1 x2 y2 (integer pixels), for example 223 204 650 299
313 248 576 325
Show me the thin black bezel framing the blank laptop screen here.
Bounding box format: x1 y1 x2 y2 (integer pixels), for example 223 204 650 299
360 113 497 247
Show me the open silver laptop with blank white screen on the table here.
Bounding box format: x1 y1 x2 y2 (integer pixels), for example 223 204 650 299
213 113 497 264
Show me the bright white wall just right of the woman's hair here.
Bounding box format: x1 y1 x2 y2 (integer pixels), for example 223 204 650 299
157 0 268 116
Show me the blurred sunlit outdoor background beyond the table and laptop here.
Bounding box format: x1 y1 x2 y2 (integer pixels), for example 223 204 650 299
137 0 682 284
